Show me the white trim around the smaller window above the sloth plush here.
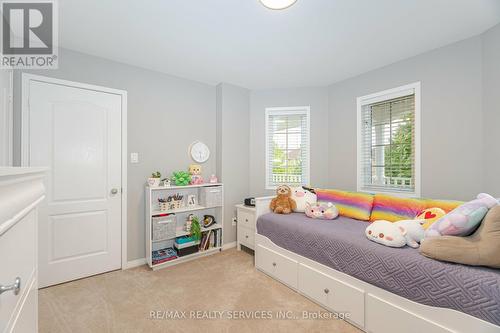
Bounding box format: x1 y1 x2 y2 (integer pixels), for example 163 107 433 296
265 106 311 190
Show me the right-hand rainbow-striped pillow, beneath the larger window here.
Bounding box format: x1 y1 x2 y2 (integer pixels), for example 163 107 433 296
370 194 427 222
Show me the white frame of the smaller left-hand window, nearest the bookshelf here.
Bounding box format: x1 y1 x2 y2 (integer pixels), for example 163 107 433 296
265 106 311 190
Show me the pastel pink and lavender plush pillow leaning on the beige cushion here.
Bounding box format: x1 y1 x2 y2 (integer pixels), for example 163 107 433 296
425 193 498 237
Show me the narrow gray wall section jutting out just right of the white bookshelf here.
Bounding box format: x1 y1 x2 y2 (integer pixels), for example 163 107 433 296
216 83 250 243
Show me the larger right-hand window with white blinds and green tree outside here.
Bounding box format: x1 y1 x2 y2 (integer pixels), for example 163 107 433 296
358 82 420 196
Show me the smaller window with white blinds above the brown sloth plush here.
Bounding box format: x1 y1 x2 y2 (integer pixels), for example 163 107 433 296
266 106 310 189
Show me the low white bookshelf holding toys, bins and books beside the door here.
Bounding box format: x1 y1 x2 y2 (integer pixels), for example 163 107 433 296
145 183 224 270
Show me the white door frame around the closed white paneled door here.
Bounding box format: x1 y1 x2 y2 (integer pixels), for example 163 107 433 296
21 73 128 269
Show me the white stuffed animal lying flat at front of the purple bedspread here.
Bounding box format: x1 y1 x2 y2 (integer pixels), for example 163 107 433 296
365 220 425 248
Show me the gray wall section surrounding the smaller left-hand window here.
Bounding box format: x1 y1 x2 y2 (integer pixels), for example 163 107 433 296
250 87 329 196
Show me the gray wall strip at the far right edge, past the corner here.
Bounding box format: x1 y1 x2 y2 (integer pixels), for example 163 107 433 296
483 25 500 197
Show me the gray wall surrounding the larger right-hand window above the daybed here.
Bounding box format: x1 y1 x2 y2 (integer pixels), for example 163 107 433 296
324 36 482 199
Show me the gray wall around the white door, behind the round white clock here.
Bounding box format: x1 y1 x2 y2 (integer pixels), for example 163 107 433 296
15 50 216 260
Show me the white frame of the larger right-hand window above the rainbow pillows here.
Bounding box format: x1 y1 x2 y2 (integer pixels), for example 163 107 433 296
356 81 422 197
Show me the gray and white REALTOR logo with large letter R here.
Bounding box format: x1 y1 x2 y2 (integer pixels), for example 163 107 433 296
0 0 58 69
